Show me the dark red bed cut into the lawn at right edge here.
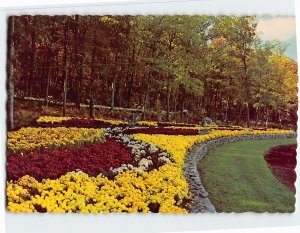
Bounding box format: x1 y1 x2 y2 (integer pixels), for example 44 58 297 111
264 144 297 192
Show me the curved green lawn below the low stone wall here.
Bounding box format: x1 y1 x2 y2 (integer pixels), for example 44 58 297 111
198 139 296 212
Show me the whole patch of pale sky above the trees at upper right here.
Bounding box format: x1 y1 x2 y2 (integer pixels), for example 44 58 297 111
256 16 297 61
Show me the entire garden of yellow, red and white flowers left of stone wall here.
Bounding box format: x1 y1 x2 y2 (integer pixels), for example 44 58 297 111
7 116 294 213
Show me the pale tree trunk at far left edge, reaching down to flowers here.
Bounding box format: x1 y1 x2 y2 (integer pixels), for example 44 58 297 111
7 16 15 130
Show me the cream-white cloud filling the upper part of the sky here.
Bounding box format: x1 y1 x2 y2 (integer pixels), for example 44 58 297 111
256 17 296 41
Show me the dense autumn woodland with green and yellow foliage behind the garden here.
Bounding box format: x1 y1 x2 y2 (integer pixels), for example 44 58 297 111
8 15 298 128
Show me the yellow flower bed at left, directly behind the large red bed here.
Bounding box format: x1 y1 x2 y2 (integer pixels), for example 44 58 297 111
7 127 104 153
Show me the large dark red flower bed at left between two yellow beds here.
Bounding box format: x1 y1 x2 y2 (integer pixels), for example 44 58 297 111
7 139 133 181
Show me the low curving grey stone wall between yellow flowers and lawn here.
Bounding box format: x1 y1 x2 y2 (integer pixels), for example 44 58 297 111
183 133 297 213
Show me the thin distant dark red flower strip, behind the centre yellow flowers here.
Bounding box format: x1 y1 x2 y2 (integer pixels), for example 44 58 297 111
124 127 198 135
